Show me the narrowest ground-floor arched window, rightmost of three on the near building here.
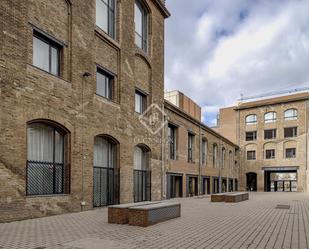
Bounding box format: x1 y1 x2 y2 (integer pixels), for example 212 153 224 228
133 145 151 202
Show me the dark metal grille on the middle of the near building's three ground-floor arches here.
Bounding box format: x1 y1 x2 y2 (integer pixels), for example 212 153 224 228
93 167 119 207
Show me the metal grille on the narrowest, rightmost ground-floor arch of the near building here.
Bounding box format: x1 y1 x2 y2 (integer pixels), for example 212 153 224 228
133 170 151 202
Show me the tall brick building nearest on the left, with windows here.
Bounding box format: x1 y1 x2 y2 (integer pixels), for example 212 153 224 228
0 0 170 222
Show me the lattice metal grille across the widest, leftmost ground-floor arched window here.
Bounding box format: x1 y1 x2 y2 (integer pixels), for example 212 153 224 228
27 161 65 195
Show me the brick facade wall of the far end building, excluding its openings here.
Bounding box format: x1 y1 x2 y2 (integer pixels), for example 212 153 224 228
237 101 308 191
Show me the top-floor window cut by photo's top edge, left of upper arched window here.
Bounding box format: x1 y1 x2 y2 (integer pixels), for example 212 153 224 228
96 0 115 38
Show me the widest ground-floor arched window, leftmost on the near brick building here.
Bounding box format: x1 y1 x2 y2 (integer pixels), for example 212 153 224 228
27 122 70 195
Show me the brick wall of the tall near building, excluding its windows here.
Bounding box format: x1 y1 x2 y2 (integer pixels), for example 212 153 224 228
0 0 164 221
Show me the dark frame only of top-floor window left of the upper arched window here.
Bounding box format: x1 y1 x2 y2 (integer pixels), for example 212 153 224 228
96 0 117 39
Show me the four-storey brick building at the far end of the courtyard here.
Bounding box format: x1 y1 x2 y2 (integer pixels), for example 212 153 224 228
215 92 309 192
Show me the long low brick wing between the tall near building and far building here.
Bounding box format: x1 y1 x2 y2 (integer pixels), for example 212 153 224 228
164 91 239 198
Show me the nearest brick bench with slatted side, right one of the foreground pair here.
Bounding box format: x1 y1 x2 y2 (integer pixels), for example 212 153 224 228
129 202 181 227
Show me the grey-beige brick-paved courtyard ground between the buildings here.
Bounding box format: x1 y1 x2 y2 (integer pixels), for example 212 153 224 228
0 193 309 249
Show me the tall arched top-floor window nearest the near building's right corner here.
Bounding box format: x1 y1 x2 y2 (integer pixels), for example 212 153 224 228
134 0 148 52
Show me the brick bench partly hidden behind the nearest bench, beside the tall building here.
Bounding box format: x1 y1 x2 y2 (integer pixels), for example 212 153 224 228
108 201 160 224
